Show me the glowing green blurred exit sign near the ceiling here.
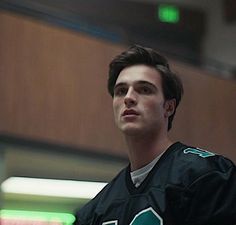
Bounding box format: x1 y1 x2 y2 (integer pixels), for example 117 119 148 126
157 4 180 23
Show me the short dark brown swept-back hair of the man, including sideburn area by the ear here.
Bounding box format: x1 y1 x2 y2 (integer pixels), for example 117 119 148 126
108 45 184 130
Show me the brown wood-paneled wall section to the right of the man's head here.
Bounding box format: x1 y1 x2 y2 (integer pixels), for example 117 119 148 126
171 63 236 162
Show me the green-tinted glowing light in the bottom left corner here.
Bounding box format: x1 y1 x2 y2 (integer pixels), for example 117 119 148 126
0 209 75 225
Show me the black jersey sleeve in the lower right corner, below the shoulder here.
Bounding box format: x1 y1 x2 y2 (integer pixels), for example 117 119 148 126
184 159 236 225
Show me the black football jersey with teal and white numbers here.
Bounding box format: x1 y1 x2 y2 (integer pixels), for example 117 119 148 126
75 142 236 225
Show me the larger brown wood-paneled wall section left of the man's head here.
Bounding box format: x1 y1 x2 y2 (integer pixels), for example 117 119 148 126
0 13 127 154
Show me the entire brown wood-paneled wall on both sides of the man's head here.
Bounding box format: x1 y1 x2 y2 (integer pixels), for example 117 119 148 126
0 12 236 161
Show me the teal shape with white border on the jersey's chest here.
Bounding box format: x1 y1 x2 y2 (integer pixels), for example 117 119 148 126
130 207 163 225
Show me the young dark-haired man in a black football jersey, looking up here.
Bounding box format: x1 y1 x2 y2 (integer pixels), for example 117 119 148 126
75 45 236 225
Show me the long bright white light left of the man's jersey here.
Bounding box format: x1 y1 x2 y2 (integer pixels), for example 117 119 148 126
1 177 107 199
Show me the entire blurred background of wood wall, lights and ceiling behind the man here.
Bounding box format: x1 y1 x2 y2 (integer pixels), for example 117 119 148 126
0 0 236 225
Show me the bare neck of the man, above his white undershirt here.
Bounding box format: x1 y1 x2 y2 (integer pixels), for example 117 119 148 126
125 132 173 171
